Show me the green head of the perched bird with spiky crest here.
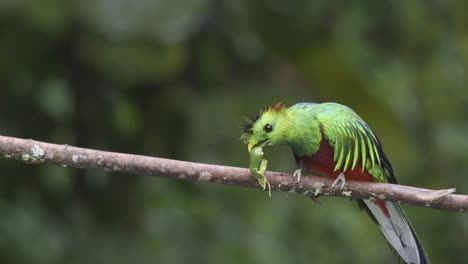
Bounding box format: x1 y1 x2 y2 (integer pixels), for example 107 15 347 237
241 102 290 152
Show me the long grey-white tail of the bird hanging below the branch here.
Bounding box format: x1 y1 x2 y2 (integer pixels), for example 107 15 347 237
360 200 429 264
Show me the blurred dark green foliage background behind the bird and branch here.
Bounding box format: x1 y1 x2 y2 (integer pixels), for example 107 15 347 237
0 0 468 264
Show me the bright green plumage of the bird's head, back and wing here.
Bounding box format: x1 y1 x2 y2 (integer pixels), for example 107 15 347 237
242 103 396 182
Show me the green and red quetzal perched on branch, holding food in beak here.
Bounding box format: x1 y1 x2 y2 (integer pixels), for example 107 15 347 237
241 102 429 264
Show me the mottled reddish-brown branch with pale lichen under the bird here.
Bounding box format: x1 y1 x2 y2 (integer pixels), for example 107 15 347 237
0 136 468 213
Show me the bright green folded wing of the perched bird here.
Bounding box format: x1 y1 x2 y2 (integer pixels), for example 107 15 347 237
317 107 396 183
